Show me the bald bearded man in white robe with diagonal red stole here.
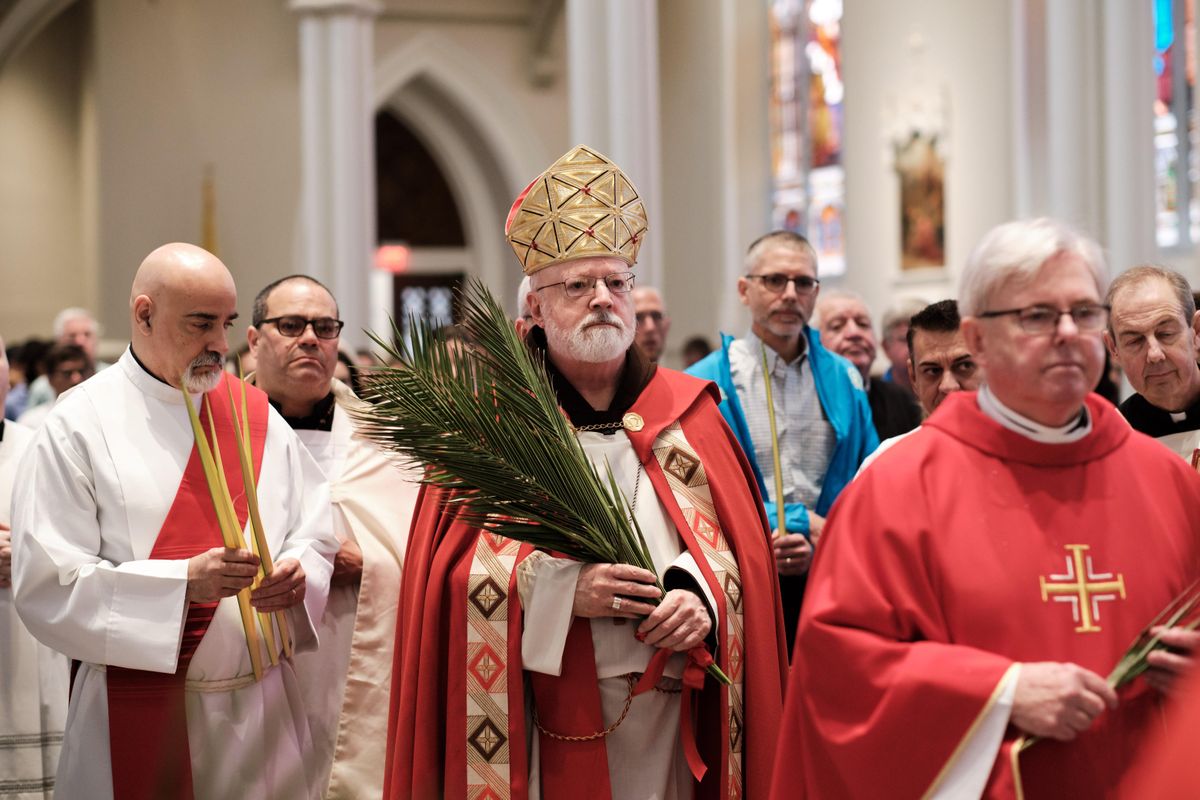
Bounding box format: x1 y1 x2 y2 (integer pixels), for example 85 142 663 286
12 243 337 800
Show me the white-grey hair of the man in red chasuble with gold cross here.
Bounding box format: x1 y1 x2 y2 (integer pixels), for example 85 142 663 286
959 217 1108 317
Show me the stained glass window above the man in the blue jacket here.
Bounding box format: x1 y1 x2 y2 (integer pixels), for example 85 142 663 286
769 0 846 276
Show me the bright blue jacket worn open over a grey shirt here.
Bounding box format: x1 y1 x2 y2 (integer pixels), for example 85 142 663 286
686 326 880 535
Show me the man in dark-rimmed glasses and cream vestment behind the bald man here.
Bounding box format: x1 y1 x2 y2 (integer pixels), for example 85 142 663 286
246 275 420 798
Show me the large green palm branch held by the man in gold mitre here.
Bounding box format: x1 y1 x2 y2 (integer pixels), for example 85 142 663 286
352 279 728 682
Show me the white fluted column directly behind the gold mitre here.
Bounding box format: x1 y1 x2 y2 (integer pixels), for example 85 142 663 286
566 0 664 285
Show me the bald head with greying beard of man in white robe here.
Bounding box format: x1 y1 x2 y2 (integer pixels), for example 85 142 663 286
130 242 238 392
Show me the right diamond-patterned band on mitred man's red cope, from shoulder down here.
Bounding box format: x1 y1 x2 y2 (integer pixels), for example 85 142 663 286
654 422 745 799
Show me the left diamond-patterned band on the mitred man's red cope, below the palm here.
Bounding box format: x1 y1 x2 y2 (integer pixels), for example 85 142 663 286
467 533 521 800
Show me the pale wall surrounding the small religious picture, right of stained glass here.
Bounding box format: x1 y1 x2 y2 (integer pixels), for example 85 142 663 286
841 0 1015 338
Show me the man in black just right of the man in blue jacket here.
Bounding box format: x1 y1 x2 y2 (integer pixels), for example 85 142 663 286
816 289 920 441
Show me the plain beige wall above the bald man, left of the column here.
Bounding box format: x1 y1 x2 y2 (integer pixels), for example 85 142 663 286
95 0 300 345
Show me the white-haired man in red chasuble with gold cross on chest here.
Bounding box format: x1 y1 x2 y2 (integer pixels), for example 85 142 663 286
773 219 1200 798
